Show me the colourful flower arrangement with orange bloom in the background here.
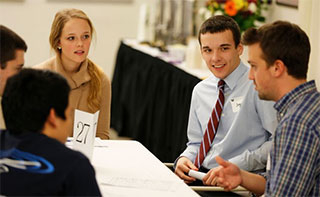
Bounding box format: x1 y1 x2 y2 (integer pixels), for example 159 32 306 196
199 0 271 32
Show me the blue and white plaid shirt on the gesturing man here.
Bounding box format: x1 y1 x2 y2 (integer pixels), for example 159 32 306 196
265 81 320 197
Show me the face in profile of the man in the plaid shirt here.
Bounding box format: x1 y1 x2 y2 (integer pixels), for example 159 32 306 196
248 43 276 100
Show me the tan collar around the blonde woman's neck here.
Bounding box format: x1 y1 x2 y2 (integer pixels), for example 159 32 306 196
54 56 91 89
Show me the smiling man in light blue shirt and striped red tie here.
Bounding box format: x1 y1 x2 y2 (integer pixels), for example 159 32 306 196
174 16 277 184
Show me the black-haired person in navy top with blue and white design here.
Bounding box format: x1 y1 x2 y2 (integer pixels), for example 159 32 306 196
0 69 101 196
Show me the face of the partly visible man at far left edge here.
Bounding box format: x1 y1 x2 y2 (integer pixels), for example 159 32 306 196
0 49 25 96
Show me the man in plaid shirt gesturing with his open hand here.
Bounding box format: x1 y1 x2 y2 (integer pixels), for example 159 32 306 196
205 21 320 196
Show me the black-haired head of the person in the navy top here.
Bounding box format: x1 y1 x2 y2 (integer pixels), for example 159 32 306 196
2 69 70 141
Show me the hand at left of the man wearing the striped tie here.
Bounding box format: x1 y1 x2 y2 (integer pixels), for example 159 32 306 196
174 157 198 184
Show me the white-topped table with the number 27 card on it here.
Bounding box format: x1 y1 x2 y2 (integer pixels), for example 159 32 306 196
91 140 199 197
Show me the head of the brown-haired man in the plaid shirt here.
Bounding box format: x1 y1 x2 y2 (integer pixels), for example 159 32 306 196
242 21 311 101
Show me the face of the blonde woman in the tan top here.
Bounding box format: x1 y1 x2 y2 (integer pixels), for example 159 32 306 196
59 18 92 73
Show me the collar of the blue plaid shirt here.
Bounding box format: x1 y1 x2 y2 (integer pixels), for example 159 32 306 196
274 80 317 119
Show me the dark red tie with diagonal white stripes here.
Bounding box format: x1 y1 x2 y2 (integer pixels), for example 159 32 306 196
194 80 225 168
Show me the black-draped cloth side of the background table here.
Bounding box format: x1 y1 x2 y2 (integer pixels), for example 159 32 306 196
111 42 200 162
